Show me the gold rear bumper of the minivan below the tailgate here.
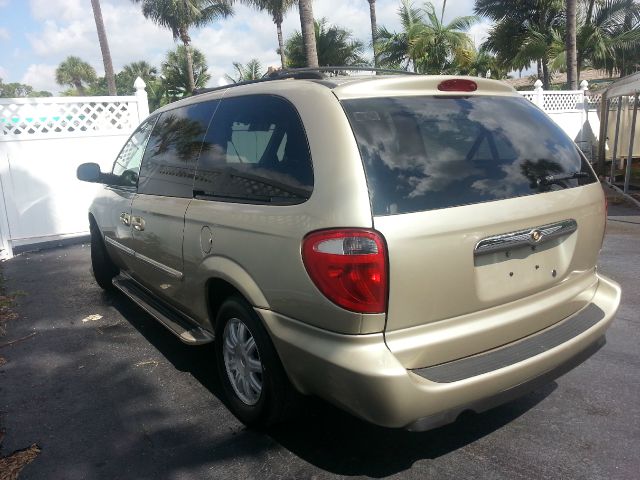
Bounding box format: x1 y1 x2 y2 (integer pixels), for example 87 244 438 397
257 276 620 430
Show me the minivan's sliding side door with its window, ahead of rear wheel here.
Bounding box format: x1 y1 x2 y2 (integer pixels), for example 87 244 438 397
131 101 218 303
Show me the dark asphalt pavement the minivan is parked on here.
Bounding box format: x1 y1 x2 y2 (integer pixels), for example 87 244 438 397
0 206 640 480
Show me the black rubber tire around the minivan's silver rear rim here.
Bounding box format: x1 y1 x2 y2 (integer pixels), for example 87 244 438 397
215 297 299 427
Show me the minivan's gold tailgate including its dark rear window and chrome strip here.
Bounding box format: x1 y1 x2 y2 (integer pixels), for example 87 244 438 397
343 96 604 346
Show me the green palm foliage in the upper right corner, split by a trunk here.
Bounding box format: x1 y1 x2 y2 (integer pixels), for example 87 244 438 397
475 0 640 83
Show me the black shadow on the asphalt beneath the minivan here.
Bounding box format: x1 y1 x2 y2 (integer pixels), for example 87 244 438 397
108 288 557 478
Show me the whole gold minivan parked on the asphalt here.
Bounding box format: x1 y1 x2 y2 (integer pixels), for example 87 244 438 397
78 69 620 430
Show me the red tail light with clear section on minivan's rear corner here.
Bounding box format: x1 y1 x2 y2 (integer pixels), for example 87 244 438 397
302 229 387 313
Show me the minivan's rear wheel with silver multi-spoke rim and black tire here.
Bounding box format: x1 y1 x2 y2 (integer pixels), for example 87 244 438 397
215 297 297 427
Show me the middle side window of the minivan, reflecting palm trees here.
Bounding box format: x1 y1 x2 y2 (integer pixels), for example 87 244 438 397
138 101 219 198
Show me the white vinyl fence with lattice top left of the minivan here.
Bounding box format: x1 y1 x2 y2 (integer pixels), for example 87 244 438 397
0 79 149 258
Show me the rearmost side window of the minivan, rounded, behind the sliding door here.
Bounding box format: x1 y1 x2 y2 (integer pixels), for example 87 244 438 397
193 95 313 205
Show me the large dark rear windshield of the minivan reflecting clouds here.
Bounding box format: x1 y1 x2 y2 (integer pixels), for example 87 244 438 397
342 96 596 215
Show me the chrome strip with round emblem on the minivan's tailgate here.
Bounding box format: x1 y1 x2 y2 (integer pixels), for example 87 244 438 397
473 219 578 256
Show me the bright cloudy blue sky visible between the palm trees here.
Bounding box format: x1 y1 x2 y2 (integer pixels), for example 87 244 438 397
0 0 490 94
